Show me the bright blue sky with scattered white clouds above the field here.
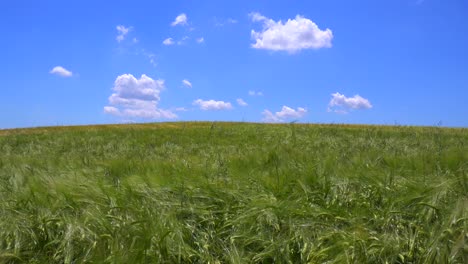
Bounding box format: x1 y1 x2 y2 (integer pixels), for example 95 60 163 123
0 0 468 128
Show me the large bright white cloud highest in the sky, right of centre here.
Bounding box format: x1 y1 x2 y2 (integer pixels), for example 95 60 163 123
250 13 333 53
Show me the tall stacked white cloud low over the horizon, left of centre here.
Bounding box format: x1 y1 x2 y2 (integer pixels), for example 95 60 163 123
104 74 177 119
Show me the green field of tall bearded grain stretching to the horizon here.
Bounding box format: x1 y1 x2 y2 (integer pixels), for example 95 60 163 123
0 122 468 263
